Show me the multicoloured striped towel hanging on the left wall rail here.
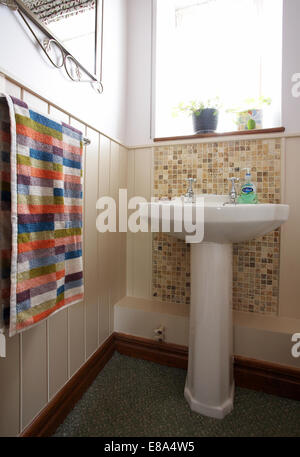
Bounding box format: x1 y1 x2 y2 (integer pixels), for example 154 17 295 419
0 95 83 336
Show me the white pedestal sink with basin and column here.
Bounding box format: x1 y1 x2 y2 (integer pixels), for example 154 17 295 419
143 195 289 419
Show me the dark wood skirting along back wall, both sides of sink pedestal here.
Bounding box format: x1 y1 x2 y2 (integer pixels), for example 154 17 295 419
115 333 300 400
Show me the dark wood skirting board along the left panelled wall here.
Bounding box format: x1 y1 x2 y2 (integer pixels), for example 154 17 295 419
20 335 115 437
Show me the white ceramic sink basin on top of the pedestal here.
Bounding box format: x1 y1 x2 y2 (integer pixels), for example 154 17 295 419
144 195 289 243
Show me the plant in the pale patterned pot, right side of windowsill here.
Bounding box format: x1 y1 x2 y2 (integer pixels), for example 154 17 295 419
227 97 272 130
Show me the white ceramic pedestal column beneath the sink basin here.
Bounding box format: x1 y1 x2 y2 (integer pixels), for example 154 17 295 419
184 242 234 419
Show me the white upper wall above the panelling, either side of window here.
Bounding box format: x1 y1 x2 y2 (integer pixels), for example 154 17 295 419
0 0 300 145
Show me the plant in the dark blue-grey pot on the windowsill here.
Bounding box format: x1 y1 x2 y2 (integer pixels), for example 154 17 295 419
175 97 220 134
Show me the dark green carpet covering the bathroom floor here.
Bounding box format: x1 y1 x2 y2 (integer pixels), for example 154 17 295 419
54 353 300 437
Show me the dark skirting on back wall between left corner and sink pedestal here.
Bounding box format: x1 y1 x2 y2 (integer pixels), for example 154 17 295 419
115 333 188 369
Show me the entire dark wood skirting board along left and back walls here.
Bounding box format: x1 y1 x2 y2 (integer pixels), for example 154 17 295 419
20 333 300 437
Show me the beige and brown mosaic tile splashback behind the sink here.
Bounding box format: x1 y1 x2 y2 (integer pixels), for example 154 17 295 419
152 139 281 314
